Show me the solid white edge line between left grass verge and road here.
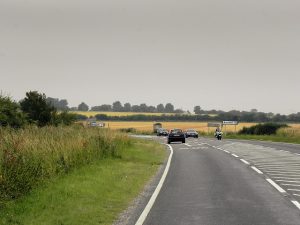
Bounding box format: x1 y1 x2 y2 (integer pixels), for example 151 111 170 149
135 145 173 225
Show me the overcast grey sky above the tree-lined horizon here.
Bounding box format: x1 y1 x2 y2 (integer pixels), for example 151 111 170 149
0 0 300 114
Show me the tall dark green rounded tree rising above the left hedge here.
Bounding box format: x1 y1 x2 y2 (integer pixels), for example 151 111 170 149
20 91 56 126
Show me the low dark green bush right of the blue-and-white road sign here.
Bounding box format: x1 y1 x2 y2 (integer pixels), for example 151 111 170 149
239 123 288 135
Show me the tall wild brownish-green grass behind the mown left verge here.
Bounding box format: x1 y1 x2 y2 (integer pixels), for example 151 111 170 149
0 126 131 201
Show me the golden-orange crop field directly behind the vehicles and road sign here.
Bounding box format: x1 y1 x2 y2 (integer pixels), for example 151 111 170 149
102 121 256 132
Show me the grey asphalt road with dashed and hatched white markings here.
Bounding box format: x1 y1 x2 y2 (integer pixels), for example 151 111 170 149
144 138 300 225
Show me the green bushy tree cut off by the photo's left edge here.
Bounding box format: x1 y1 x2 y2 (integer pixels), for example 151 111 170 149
0 95 26 128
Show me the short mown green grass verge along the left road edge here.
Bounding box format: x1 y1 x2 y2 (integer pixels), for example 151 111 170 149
0 140 166 225
